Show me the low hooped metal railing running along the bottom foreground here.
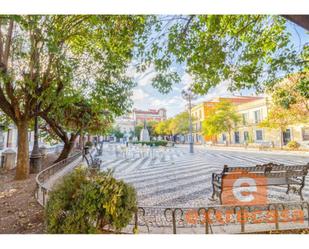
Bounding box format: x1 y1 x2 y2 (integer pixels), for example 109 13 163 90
128 201 309 234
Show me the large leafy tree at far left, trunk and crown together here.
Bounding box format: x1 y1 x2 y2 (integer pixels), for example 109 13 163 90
0 15 144 179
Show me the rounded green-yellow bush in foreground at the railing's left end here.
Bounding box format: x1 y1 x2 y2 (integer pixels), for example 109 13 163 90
45 168 137 234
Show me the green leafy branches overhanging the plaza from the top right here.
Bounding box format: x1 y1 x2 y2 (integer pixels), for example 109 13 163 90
140 15 308 94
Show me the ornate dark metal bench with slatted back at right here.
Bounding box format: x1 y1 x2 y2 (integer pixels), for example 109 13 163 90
209 163 309 204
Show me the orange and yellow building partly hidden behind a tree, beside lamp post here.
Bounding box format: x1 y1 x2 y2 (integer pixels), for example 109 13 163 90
192 96 263 144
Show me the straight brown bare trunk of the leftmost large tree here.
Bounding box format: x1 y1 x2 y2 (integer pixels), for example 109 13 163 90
15 121 30 180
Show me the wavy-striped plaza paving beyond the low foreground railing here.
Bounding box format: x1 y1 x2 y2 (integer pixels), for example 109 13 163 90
101 147 309 207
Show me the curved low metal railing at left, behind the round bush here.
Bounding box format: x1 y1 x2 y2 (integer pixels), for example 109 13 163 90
35 152 82 207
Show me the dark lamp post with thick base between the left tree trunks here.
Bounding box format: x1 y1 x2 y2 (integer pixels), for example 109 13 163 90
30 106 42 173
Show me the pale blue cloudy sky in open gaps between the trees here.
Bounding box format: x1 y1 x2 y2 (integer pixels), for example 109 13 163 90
132 18 309 117
